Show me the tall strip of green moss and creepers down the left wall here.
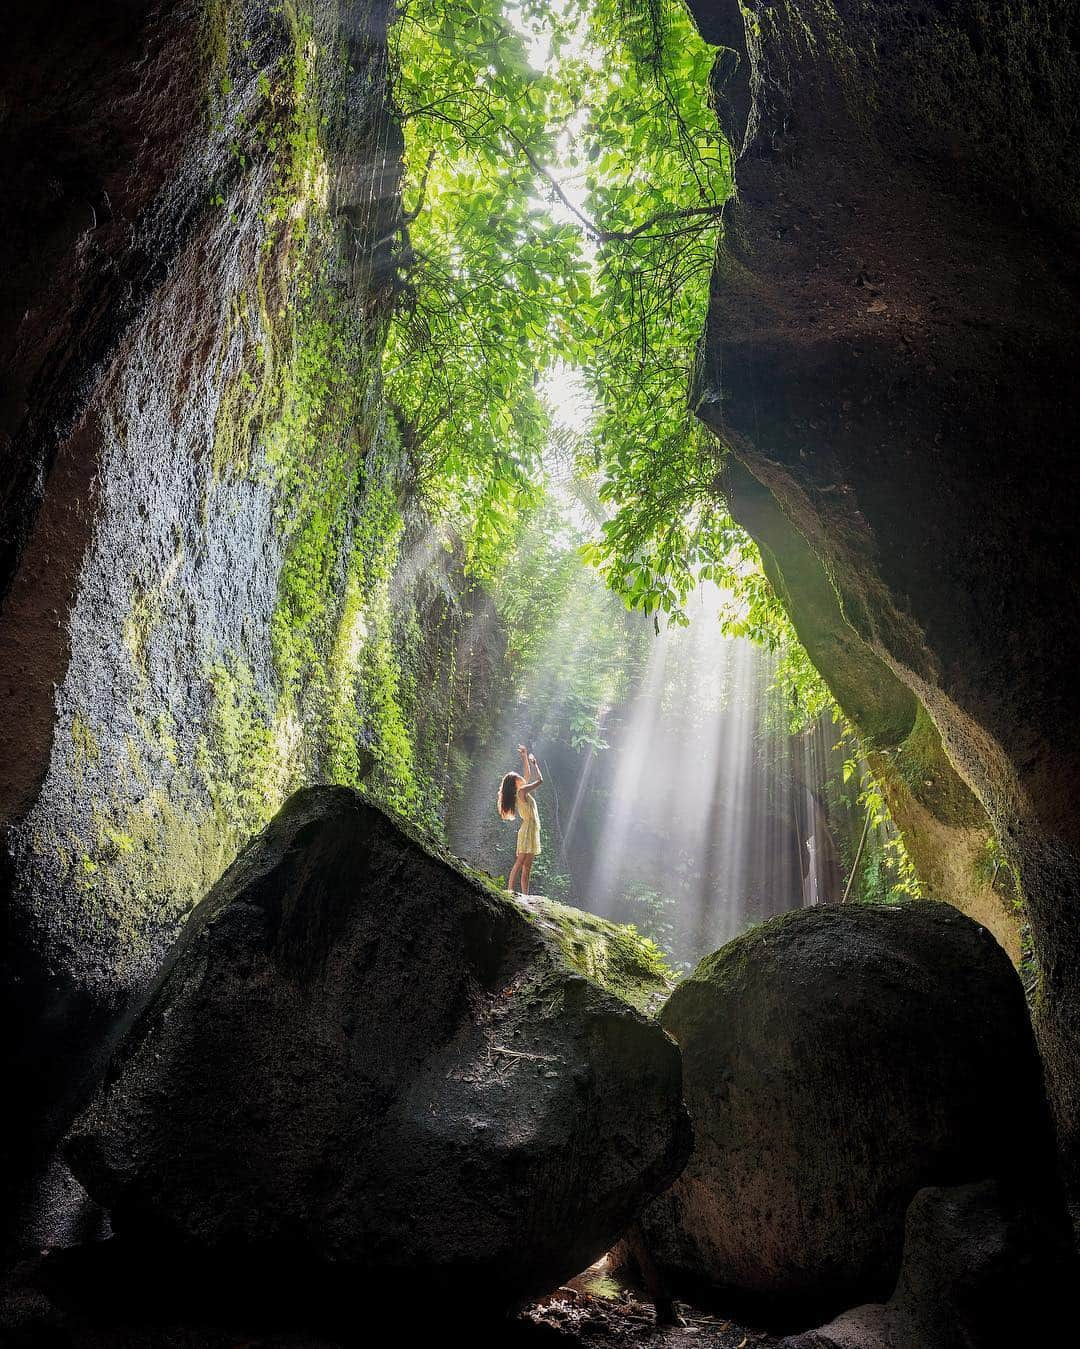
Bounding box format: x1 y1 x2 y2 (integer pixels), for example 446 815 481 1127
202 3 421 819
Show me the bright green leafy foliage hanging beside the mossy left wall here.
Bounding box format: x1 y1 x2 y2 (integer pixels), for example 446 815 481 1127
386 0 577 572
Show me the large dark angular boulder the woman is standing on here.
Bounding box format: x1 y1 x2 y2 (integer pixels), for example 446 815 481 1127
69 788 690 1306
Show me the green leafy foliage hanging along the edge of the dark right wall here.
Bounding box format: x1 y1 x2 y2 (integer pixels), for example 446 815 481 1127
568 3 728 619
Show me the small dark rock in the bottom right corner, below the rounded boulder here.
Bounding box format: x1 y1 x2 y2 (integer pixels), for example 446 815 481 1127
785 1180 1075 1349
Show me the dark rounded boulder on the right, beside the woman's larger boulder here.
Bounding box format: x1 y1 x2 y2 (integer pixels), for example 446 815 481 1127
644 901 1053 1326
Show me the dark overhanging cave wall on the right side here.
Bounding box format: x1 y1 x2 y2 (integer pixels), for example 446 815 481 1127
692 0 1080 1166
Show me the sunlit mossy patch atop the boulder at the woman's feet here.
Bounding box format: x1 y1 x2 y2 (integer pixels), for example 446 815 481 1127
522 898 676 1014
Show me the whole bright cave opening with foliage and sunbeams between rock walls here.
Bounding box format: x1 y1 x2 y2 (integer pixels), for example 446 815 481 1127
388 4 920 969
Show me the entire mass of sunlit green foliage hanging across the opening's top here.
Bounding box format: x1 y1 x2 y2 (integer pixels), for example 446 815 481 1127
387 0 829 726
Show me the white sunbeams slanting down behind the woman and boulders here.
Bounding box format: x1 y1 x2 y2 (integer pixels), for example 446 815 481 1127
449 553 839 965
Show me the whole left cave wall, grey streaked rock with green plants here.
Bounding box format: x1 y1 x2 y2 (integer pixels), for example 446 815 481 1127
0 0 413 1244
